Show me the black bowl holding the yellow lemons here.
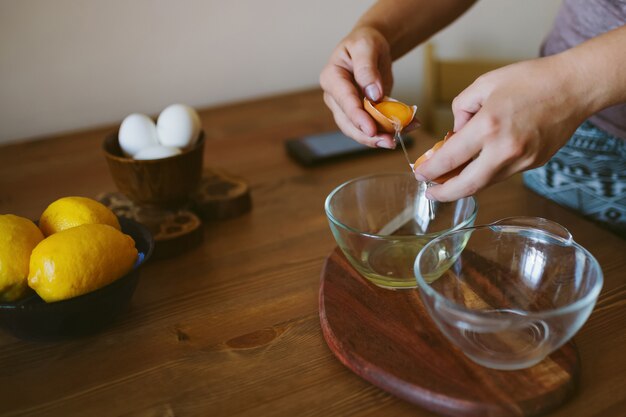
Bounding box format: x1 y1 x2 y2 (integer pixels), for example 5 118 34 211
0 217 154 341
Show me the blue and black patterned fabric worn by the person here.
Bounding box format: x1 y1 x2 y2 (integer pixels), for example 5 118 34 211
524 121 626 238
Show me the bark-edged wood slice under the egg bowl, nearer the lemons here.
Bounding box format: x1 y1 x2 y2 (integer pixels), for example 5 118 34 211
97 192 203 259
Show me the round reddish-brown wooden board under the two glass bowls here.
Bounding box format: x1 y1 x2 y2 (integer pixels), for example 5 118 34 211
319 248 579 417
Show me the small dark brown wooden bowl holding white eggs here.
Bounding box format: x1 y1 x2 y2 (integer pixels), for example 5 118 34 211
102 131 204 207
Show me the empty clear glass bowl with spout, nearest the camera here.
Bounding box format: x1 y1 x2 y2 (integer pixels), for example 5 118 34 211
414 217 603 370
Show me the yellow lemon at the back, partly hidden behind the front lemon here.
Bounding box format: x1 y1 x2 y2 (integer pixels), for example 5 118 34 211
39 197 121 236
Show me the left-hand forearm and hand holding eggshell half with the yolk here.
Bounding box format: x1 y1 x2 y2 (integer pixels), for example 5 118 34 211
320 0 476 149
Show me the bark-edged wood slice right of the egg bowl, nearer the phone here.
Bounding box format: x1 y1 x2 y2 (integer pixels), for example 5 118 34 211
191 168 252 220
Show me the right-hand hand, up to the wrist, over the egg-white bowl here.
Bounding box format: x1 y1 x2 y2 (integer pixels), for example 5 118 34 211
415 55 590 201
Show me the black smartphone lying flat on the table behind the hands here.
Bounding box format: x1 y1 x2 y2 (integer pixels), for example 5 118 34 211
285 131 413 166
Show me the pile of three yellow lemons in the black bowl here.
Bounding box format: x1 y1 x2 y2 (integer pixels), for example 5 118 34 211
0 197 138 302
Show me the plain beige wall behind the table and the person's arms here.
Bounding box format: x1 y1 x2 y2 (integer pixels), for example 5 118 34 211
0 0 559 142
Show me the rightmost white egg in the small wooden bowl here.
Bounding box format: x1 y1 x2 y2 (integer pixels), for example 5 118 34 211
157 104 200 149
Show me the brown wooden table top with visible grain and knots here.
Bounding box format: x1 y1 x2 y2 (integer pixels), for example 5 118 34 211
0 90 626 417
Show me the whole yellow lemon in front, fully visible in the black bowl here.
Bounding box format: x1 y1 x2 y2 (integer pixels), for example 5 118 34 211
28 223 137 302
